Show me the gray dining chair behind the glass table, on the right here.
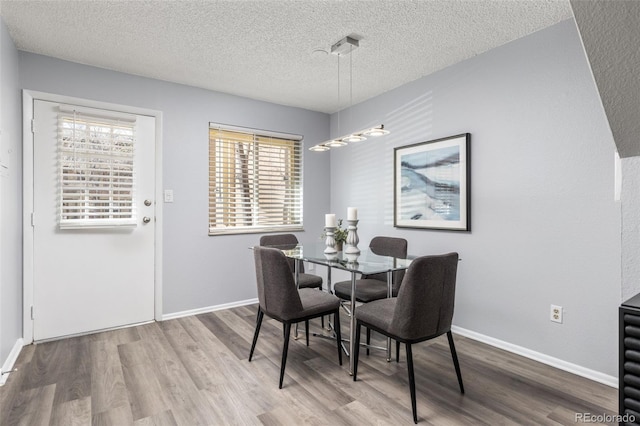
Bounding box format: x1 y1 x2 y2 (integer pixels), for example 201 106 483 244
333 236 407 357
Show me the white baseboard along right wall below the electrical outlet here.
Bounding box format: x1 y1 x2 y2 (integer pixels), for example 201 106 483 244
451 325 618 389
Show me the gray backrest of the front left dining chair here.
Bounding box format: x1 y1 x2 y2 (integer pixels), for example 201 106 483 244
253 246 302 319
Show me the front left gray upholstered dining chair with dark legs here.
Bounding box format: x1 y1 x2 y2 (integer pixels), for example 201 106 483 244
249 247 342 389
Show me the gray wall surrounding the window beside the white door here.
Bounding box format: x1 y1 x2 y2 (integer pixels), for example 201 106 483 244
20 52 329 314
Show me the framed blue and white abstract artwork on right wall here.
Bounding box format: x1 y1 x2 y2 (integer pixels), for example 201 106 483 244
393 133 471 232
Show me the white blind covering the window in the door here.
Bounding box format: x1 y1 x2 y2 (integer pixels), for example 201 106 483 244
58 111 136 229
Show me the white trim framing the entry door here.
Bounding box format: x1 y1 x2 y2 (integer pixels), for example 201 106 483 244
22 90 163 345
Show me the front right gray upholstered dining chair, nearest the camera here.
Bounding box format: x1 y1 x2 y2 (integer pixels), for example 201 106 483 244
353 253 464 423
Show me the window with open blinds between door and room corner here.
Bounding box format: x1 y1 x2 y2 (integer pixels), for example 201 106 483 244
209 123 302 235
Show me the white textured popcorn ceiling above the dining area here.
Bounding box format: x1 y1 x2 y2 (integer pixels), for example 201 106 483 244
0 0 573 113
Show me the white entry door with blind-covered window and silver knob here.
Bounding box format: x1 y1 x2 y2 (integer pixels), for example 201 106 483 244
33 100 155 341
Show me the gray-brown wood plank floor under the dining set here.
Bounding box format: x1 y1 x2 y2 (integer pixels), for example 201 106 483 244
0 306 617 426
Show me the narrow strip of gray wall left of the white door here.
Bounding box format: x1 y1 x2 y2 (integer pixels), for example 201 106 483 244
0 18 22 366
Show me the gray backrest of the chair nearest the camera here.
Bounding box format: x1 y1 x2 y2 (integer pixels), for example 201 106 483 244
390 253 458 339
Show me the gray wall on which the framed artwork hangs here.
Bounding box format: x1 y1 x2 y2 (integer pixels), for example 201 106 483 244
330 20 621 376
